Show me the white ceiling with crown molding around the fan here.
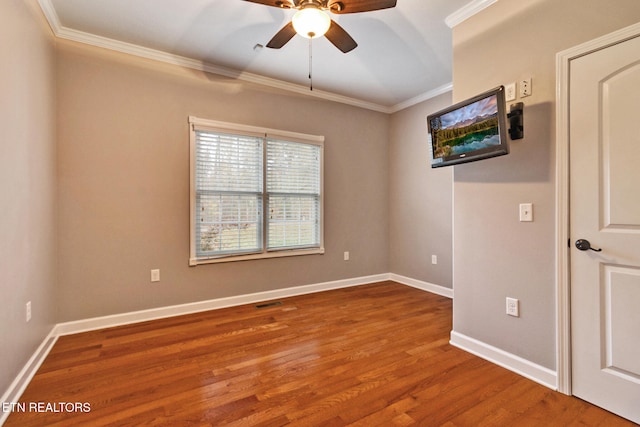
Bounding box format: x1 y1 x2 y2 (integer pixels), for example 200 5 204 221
40 0 496 112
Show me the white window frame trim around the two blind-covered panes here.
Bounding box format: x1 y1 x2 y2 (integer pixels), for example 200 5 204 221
189 116 325 266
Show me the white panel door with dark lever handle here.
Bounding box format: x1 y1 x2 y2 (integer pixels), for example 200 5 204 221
569 37 640 423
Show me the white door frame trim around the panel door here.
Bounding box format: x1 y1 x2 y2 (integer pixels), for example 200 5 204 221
556 23 640 395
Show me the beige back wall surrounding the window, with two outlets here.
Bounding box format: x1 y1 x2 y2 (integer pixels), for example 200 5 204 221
57 41 389 321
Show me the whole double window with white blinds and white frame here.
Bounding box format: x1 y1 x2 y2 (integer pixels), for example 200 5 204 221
189 117 324 265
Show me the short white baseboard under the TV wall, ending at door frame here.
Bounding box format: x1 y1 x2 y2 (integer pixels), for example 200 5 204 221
449 331 558 390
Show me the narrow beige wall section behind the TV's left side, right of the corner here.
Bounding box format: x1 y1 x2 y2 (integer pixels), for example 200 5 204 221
389 92 453 288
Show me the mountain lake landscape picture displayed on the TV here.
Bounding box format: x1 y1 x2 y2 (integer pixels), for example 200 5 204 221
429 94 500 159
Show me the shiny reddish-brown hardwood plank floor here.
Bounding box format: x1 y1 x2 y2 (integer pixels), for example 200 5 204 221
6 282 634 427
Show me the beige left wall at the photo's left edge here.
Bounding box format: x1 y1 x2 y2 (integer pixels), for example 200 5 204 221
0 0 56 393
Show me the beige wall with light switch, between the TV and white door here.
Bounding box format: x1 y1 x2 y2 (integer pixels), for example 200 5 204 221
453 0 640 369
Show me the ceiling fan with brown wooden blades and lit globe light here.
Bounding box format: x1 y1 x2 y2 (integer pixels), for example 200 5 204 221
245 0 397 53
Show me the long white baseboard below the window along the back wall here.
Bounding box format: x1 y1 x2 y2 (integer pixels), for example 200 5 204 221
54 274 389 336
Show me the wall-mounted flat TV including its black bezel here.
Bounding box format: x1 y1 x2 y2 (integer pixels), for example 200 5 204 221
427 86 509 168
